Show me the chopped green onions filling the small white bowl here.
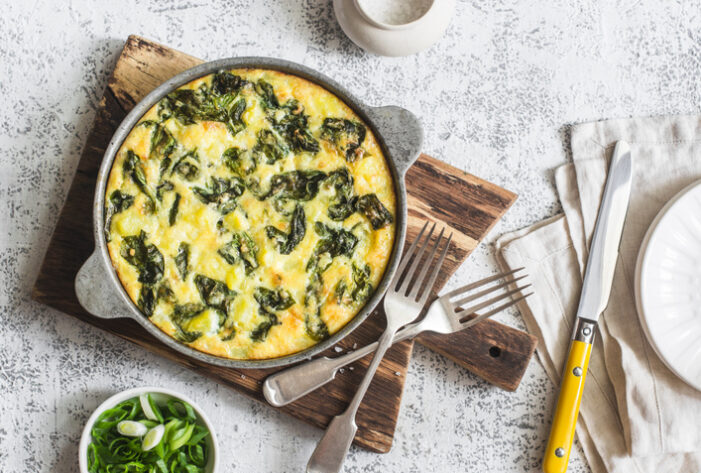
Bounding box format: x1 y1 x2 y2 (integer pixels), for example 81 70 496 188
87 395 210 473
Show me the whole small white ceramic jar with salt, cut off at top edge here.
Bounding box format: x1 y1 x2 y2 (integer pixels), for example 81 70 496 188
333 0 455 56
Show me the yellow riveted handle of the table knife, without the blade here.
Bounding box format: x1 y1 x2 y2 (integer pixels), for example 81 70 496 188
543 320 596 473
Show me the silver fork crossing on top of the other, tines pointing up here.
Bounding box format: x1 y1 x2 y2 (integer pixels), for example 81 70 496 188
307 222 453 473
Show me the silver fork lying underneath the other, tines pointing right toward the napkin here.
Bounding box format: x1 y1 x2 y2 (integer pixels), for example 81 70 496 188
263 268 531 407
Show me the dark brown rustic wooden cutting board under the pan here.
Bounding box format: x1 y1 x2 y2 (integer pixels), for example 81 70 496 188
33 36 536 452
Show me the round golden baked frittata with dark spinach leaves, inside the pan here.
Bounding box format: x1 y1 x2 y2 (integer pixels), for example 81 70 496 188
105 69 396 359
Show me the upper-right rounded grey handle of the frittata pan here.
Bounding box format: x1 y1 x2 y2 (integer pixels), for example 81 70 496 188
366 105 424 178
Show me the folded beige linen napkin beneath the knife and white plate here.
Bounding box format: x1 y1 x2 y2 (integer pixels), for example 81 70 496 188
497 116 701 473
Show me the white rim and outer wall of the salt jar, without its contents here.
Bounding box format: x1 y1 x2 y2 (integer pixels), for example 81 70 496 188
333 0 455 56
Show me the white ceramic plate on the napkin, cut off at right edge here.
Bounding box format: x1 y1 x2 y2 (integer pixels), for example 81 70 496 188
635 181 701 390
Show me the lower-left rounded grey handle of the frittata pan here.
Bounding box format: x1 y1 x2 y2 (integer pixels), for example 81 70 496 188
75 249 133 319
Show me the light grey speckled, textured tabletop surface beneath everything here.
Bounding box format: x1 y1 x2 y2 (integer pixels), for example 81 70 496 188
0 0 701 473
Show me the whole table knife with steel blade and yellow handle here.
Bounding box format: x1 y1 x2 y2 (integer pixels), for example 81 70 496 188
543 141 633 473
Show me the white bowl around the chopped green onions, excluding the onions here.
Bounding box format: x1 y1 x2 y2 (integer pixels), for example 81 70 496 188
78 387 219 473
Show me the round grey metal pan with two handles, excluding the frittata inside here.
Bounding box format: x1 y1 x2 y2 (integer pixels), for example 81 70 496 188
75 57 423 369
